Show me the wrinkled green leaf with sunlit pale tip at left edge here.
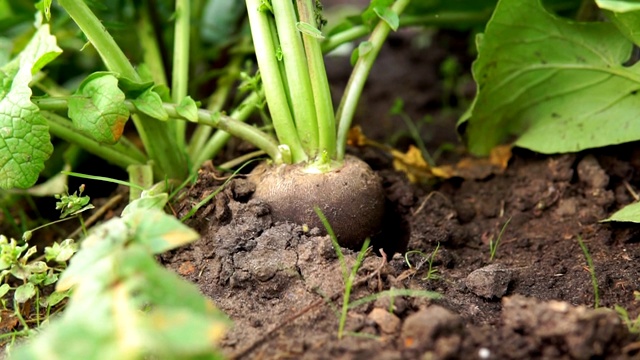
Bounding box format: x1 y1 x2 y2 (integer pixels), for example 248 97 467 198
0 25 62 189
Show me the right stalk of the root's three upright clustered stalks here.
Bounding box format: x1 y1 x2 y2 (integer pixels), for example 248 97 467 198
297 0 336 159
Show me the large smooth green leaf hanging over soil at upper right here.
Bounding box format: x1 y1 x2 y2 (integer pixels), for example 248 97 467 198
459 0 640 155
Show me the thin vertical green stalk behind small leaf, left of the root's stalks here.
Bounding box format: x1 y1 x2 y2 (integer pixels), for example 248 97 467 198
169 0 191 149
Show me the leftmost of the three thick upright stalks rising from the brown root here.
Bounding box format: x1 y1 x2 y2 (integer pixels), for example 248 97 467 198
246 0 308 162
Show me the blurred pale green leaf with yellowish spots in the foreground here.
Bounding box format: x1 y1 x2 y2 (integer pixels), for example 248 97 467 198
12 196 229 360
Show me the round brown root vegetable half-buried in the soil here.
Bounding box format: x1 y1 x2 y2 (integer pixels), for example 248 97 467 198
250 156 385 248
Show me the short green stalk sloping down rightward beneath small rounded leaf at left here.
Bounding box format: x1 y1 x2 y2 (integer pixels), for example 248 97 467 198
41 111 147 169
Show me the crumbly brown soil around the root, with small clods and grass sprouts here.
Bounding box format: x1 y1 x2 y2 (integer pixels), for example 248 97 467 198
163 146 640 359
